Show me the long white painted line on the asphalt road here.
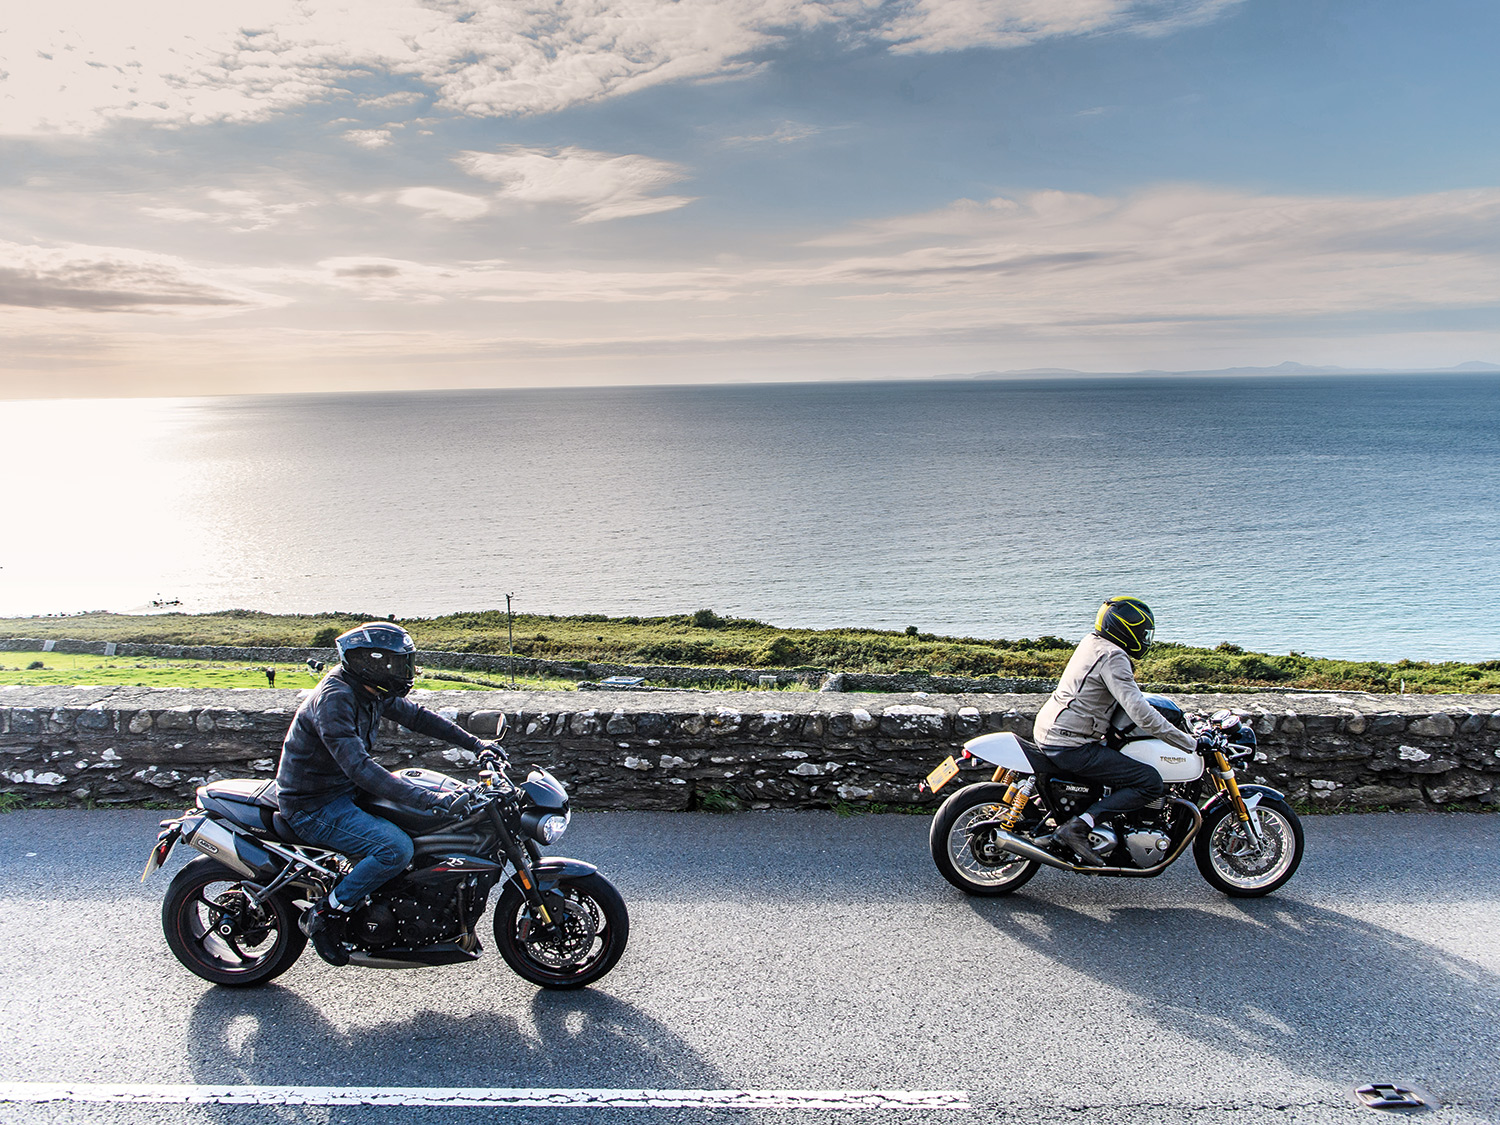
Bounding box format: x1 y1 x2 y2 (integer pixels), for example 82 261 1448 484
0 1082 969 1110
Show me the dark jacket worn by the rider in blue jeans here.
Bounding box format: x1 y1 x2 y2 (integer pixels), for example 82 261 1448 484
276 669 480 816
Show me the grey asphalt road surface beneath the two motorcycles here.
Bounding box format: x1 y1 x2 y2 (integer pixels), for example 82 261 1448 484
0 812 1500 1125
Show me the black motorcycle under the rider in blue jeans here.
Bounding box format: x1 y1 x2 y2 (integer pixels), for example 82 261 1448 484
141 728 630 989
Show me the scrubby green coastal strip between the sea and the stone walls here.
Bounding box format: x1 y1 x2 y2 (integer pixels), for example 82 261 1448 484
0 609 1500 693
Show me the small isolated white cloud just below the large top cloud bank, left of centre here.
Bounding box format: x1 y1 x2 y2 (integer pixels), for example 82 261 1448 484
456 146 693 222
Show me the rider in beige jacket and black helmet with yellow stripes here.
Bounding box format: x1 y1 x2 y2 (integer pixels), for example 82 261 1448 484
1032 596 1197 867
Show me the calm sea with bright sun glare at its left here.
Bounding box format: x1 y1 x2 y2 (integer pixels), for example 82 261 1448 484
0 375 1500 659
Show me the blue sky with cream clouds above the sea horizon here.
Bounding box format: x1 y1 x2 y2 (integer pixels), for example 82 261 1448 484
0 0 1500 399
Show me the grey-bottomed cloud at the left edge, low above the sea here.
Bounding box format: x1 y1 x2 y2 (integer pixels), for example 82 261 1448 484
0 242 276 314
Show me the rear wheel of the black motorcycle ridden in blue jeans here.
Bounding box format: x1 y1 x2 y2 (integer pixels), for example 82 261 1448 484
162 855 308 989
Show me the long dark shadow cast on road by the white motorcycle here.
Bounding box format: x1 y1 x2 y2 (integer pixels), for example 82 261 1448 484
969 897 1500 1106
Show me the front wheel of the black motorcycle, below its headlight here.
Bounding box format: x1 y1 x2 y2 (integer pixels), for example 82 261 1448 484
495 873 630 989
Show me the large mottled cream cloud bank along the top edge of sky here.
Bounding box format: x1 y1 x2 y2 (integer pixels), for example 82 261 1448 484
0 0 1241 134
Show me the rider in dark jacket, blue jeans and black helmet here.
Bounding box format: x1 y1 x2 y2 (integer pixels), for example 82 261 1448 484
276 621 504 965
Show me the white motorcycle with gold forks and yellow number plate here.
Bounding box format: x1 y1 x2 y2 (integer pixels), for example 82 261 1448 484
923 696 1302 899
